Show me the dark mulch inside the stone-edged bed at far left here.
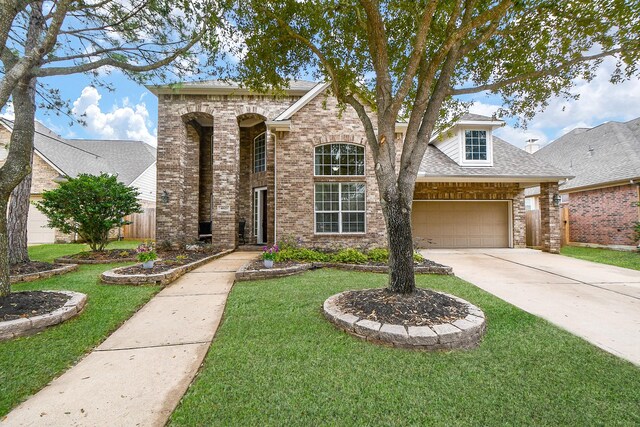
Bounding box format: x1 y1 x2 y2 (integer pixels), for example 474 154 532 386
0 291 71 321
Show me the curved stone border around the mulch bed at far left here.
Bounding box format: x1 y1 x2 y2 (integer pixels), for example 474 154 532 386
0 291 87 341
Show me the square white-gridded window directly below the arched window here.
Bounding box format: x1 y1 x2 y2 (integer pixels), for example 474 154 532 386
315 182 366 233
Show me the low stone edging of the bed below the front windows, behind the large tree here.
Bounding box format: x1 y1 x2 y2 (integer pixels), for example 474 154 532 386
236 262 453 282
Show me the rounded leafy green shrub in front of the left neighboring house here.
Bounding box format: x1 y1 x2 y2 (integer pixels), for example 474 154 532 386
35 174 142 251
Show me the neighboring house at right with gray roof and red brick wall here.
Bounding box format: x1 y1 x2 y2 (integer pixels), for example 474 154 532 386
527 118 640 247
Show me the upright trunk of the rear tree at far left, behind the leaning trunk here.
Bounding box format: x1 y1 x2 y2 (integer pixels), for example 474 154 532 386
7 170 33 264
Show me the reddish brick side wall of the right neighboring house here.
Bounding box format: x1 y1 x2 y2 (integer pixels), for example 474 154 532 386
569 184 639 246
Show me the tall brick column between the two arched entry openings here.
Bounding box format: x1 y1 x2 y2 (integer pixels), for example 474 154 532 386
211 114 240 248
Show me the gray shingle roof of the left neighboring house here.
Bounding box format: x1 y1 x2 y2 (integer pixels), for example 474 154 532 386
0 119 156 185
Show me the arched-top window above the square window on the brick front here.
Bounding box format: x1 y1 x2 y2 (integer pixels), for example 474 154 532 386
315 144 364 176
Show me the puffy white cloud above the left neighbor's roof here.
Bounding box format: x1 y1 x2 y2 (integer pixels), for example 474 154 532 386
72 86 156 146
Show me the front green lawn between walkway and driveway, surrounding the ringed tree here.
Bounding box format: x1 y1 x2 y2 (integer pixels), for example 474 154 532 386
170 269 640 426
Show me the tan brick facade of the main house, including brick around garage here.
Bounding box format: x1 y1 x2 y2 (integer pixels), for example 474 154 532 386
156 88 559 252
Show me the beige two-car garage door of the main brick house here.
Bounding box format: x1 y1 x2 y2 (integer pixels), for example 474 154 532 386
411 200 511 248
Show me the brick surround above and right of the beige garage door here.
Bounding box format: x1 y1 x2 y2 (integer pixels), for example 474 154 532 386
413 182 526 248
